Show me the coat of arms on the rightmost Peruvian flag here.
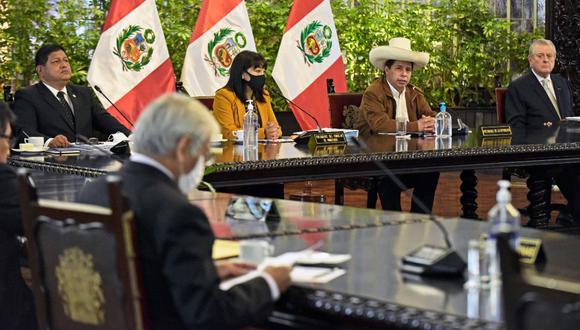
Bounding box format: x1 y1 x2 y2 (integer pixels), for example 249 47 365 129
296 21 332 66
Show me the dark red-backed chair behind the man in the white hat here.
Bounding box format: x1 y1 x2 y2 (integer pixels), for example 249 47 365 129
328 93 377 208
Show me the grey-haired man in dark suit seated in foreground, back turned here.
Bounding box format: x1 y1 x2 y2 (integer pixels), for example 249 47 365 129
80 94 290 329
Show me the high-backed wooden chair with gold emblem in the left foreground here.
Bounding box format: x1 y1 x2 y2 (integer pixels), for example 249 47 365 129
18 169 146 330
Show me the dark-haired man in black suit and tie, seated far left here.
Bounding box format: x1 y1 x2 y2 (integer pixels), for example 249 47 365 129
14 44 131 147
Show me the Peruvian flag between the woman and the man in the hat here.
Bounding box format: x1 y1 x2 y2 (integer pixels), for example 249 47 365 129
272 0 346 130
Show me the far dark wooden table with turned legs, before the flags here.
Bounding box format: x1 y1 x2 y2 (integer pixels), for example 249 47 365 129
9 122 580 224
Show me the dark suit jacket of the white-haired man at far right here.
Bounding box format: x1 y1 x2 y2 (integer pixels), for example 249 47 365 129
505 71 574 127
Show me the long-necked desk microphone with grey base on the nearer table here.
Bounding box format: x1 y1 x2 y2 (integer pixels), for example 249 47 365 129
351 137 466 276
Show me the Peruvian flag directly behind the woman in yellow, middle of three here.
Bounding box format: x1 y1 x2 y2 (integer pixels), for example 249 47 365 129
181 0 256 96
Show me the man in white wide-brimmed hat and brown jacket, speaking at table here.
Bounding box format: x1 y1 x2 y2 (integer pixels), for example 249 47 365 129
356 38 439 213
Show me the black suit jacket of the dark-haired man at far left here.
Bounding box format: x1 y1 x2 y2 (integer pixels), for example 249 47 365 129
14 83 131 142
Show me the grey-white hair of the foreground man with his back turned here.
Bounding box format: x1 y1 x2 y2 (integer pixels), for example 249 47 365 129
133 94 219 156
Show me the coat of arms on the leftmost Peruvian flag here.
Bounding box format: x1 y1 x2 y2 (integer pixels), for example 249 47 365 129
113 25 155 71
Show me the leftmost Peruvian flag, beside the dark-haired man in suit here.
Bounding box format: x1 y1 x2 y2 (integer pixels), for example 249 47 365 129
87 0 175 128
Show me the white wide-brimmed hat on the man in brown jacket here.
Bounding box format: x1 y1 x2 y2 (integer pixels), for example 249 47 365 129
369 38 429 71
